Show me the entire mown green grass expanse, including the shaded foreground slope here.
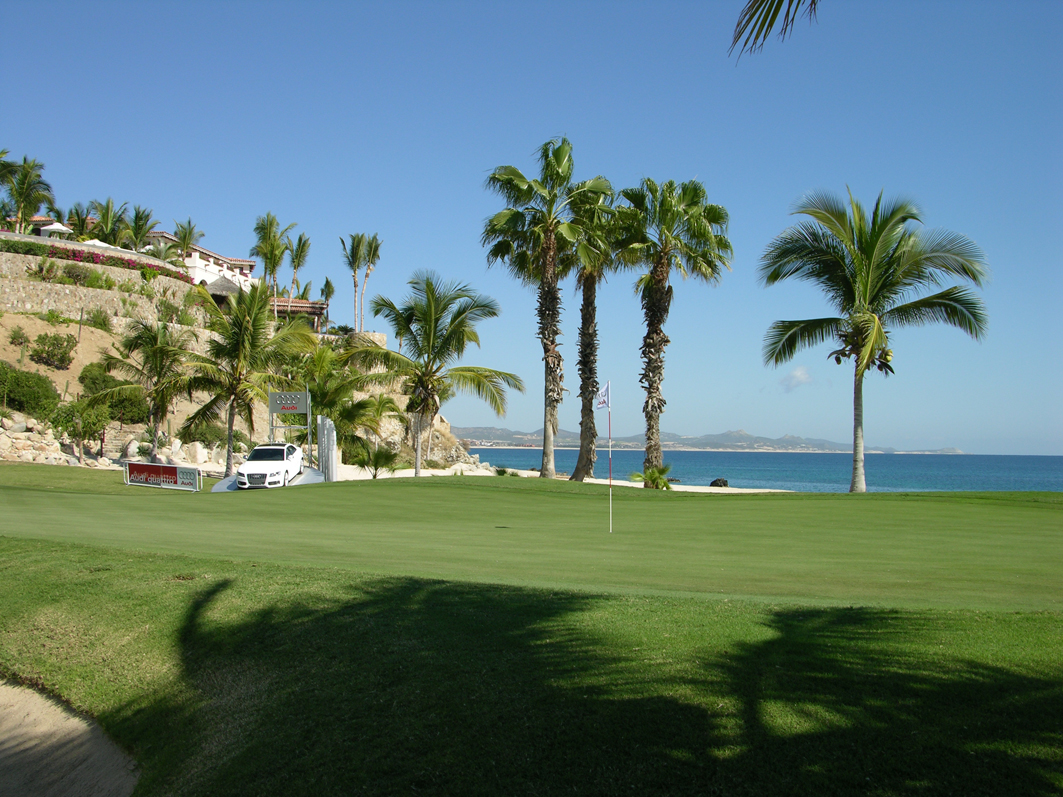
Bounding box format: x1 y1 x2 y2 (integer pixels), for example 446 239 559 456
0 468 1063 795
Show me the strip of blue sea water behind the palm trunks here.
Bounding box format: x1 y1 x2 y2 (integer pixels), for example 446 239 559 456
471 448 1063 492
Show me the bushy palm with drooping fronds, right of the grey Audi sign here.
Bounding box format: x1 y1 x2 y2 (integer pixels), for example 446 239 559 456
357 271 524 476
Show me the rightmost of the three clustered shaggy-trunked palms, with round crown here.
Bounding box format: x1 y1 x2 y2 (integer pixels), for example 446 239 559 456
619 179 731 487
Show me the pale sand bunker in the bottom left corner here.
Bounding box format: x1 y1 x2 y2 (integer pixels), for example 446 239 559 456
0 683 137 797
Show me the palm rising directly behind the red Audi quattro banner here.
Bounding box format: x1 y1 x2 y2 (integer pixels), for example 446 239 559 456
87 321 196 461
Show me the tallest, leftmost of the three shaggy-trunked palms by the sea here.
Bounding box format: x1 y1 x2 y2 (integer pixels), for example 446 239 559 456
482 138 612 478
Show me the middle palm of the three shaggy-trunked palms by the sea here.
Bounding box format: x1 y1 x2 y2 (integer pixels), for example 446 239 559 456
569 194 617 481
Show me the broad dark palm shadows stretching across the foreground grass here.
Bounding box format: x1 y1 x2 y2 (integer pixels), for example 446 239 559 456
137 578 1063 797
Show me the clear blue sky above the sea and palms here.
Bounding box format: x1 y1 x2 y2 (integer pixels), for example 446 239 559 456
0 0 1063 455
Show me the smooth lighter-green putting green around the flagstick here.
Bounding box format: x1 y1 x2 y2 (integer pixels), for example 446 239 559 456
0 465 1063 611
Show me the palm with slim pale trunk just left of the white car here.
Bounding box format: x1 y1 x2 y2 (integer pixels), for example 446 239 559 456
182 283 315 476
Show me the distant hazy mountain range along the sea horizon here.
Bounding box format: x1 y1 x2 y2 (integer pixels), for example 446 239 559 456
451 426 963 454
